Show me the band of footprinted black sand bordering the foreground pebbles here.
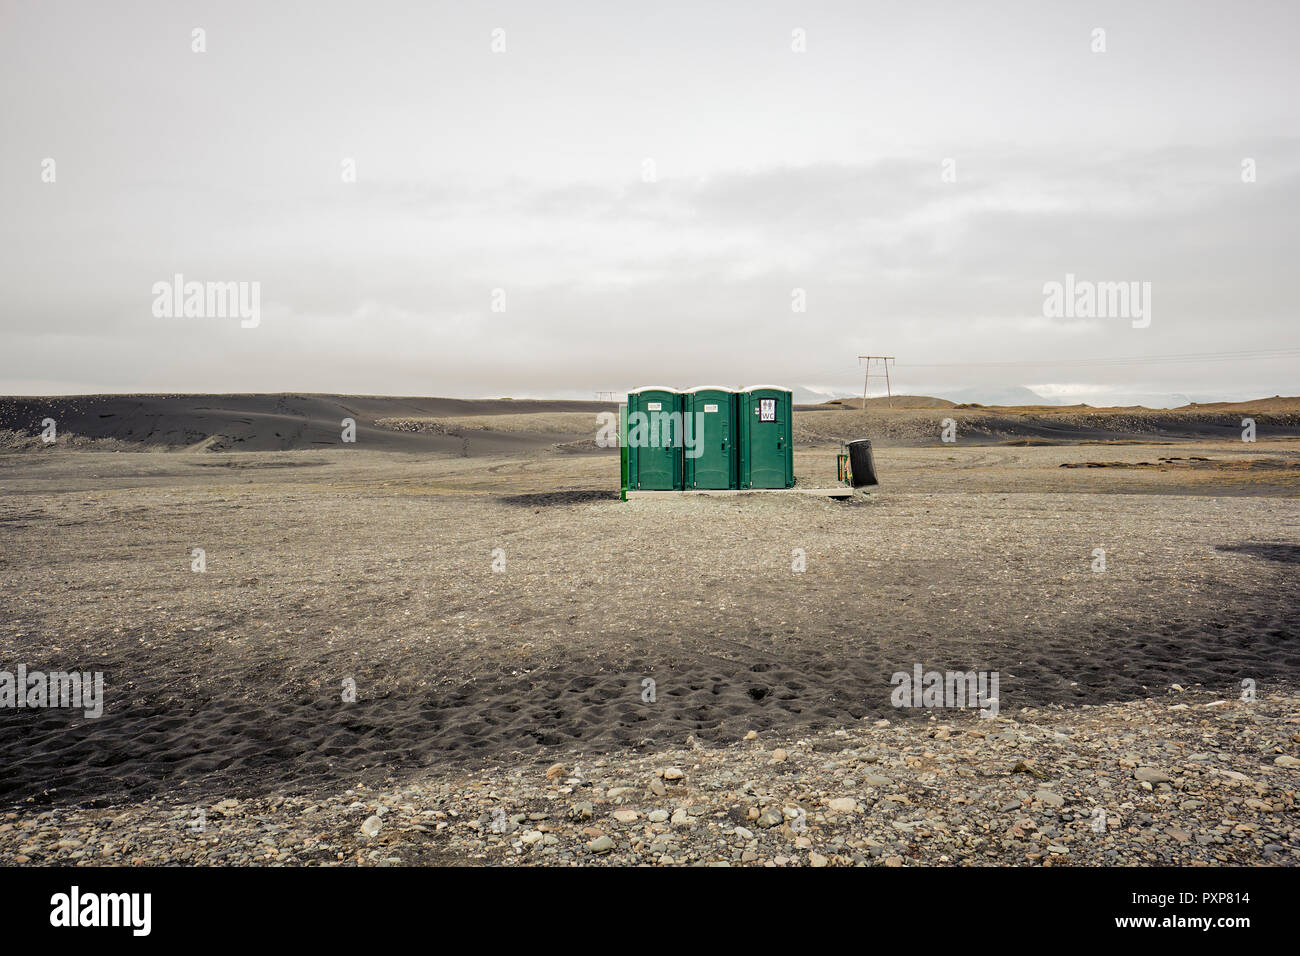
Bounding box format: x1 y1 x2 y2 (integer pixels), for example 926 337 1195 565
0 595 1300 804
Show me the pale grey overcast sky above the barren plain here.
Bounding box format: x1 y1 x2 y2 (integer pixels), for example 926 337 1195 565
0 0 1300 405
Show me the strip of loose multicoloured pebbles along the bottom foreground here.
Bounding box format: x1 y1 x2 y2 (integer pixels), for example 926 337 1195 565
0 688 1300 866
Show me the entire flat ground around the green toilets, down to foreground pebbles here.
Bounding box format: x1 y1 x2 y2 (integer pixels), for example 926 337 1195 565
0 442 1300 864
